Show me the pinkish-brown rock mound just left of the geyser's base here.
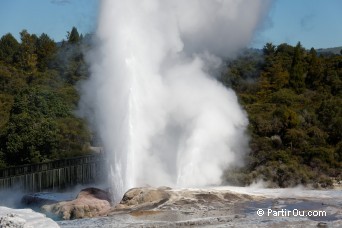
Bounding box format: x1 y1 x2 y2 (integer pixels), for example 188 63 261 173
42 188 111 220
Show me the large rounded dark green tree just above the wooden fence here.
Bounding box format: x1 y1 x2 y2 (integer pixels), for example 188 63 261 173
0 85 90 165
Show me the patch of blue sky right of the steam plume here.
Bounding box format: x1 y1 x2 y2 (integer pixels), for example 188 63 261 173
252 0 342 49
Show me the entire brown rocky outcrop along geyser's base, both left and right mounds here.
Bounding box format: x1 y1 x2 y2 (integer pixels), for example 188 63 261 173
42 187 252 220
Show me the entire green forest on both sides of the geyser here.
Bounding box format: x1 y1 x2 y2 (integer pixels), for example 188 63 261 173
0 27 342 187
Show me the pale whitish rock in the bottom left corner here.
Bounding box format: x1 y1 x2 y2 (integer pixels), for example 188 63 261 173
0 206 59 228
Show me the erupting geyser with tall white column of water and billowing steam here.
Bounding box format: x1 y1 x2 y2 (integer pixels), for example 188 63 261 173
81 0 269 200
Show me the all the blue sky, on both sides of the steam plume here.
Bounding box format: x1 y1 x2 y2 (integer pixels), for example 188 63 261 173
0 0 342 49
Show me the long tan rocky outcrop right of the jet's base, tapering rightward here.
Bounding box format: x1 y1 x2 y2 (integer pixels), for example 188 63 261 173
108 187 252 217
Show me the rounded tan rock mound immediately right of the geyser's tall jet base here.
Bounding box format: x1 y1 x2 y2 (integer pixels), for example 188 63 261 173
112 187 170 212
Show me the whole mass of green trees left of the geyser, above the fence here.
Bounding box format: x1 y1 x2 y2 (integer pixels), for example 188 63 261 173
0 30 90 168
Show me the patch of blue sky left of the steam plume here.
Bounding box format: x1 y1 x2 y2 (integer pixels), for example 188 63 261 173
0 0 99 41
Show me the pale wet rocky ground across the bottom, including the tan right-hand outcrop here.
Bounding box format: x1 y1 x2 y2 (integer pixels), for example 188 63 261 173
54 187 342 228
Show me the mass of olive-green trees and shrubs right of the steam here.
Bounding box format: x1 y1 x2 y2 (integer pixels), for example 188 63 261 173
221 43 342 187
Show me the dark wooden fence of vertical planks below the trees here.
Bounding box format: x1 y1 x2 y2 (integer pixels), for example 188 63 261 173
0 155 105 192
